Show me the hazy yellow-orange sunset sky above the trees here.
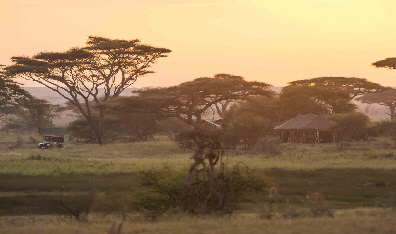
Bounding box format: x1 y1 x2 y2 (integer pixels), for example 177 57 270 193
0 0 396 87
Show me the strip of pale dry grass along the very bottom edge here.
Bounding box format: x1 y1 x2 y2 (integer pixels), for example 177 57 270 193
0 212 396 234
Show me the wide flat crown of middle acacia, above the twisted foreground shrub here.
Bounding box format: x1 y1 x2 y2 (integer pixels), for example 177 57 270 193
112 74 273 129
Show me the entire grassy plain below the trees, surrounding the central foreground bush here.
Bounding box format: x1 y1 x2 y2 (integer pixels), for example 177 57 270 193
0 133 396 233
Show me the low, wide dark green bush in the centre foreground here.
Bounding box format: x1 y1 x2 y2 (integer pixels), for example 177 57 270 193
134 163 268 216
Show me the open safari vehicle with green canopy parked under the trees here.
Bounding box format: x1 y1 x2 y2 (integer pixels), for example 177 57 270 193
38 127 67 149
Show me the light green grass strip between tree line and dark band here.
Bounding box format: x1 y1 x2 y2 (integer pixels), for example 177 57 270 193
0 141 396 176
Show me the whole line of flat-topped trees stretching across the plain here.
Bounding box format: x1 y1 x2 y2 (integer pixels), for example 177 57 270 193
0 36 396 148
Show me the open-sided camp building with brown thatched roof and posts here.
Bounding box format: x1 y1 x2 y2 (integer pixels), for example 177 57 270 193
275 114 336 143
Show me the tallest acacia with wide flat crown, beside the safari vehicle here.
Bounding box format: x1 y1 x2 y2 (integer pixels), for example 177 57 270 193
5 36 170 144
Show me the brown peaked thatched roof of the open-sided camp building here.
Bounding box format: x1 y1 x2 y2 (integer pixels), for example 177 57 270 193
275 114 335 130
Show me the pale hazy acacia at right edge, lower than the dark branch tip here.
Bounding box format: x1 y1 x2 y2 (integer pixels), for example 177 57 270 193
357 89 396 122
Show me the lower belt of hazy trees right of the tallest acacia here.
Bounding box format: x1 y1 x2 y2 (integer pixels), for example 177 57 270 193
55 74 388 146
